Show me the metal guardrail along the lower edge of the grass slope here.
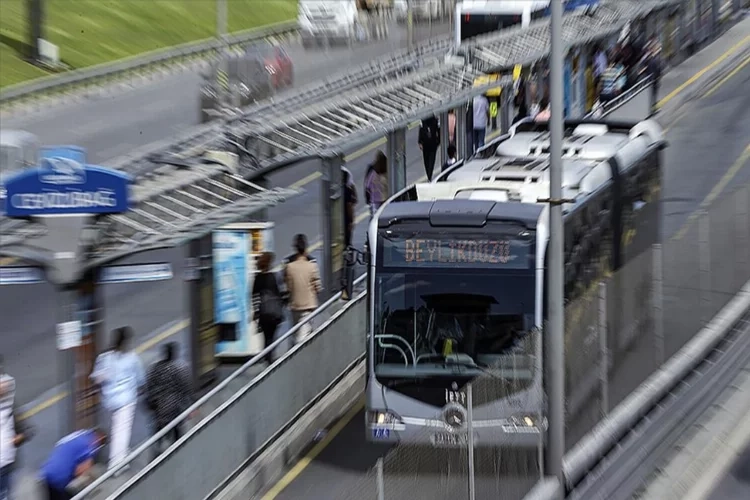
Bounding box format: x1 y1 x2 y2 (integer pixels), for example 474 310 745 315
0 21 298 107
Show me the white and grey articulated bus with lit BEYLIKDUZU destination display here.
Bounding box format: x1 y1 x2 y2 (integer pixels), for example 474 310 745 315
366 120 666 448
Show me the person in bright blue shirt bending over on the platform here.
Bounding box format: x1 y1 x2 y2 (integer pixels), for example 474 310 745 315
41 429 107 500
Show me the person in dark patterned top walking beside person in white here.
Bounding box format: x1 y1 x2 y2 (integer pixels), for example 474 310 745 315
146 342 193 457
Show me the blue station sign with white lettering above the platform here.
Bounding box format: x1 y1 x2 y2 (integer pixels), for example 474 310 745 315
4 155 130 217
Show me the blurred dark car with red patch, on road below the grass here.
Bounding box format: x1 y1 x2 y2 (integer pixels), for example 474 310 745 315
200 42 294 123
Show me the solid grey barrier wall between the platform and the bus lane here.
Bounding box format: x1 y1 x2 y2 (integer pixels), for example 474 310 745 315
90 277 366 500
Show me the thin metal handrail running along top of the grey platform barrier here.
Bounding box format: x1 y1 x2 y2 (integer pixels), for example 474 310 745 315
74 273 367 500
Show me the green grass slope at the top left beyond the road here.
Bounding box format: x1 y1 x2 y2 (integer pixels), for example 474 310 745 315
0 0 297 87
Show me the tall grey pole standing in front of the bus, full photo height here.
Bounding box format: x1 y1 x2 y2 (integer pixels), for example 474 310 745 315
546 0 565 492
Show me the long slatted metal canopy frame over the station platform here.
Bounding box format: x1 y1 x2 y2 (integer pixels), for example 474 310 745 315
0 0 679 270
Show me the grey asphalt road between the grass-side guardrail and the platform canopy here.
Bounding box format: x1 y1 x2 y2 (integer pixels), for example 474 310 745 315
2 23 449 165
